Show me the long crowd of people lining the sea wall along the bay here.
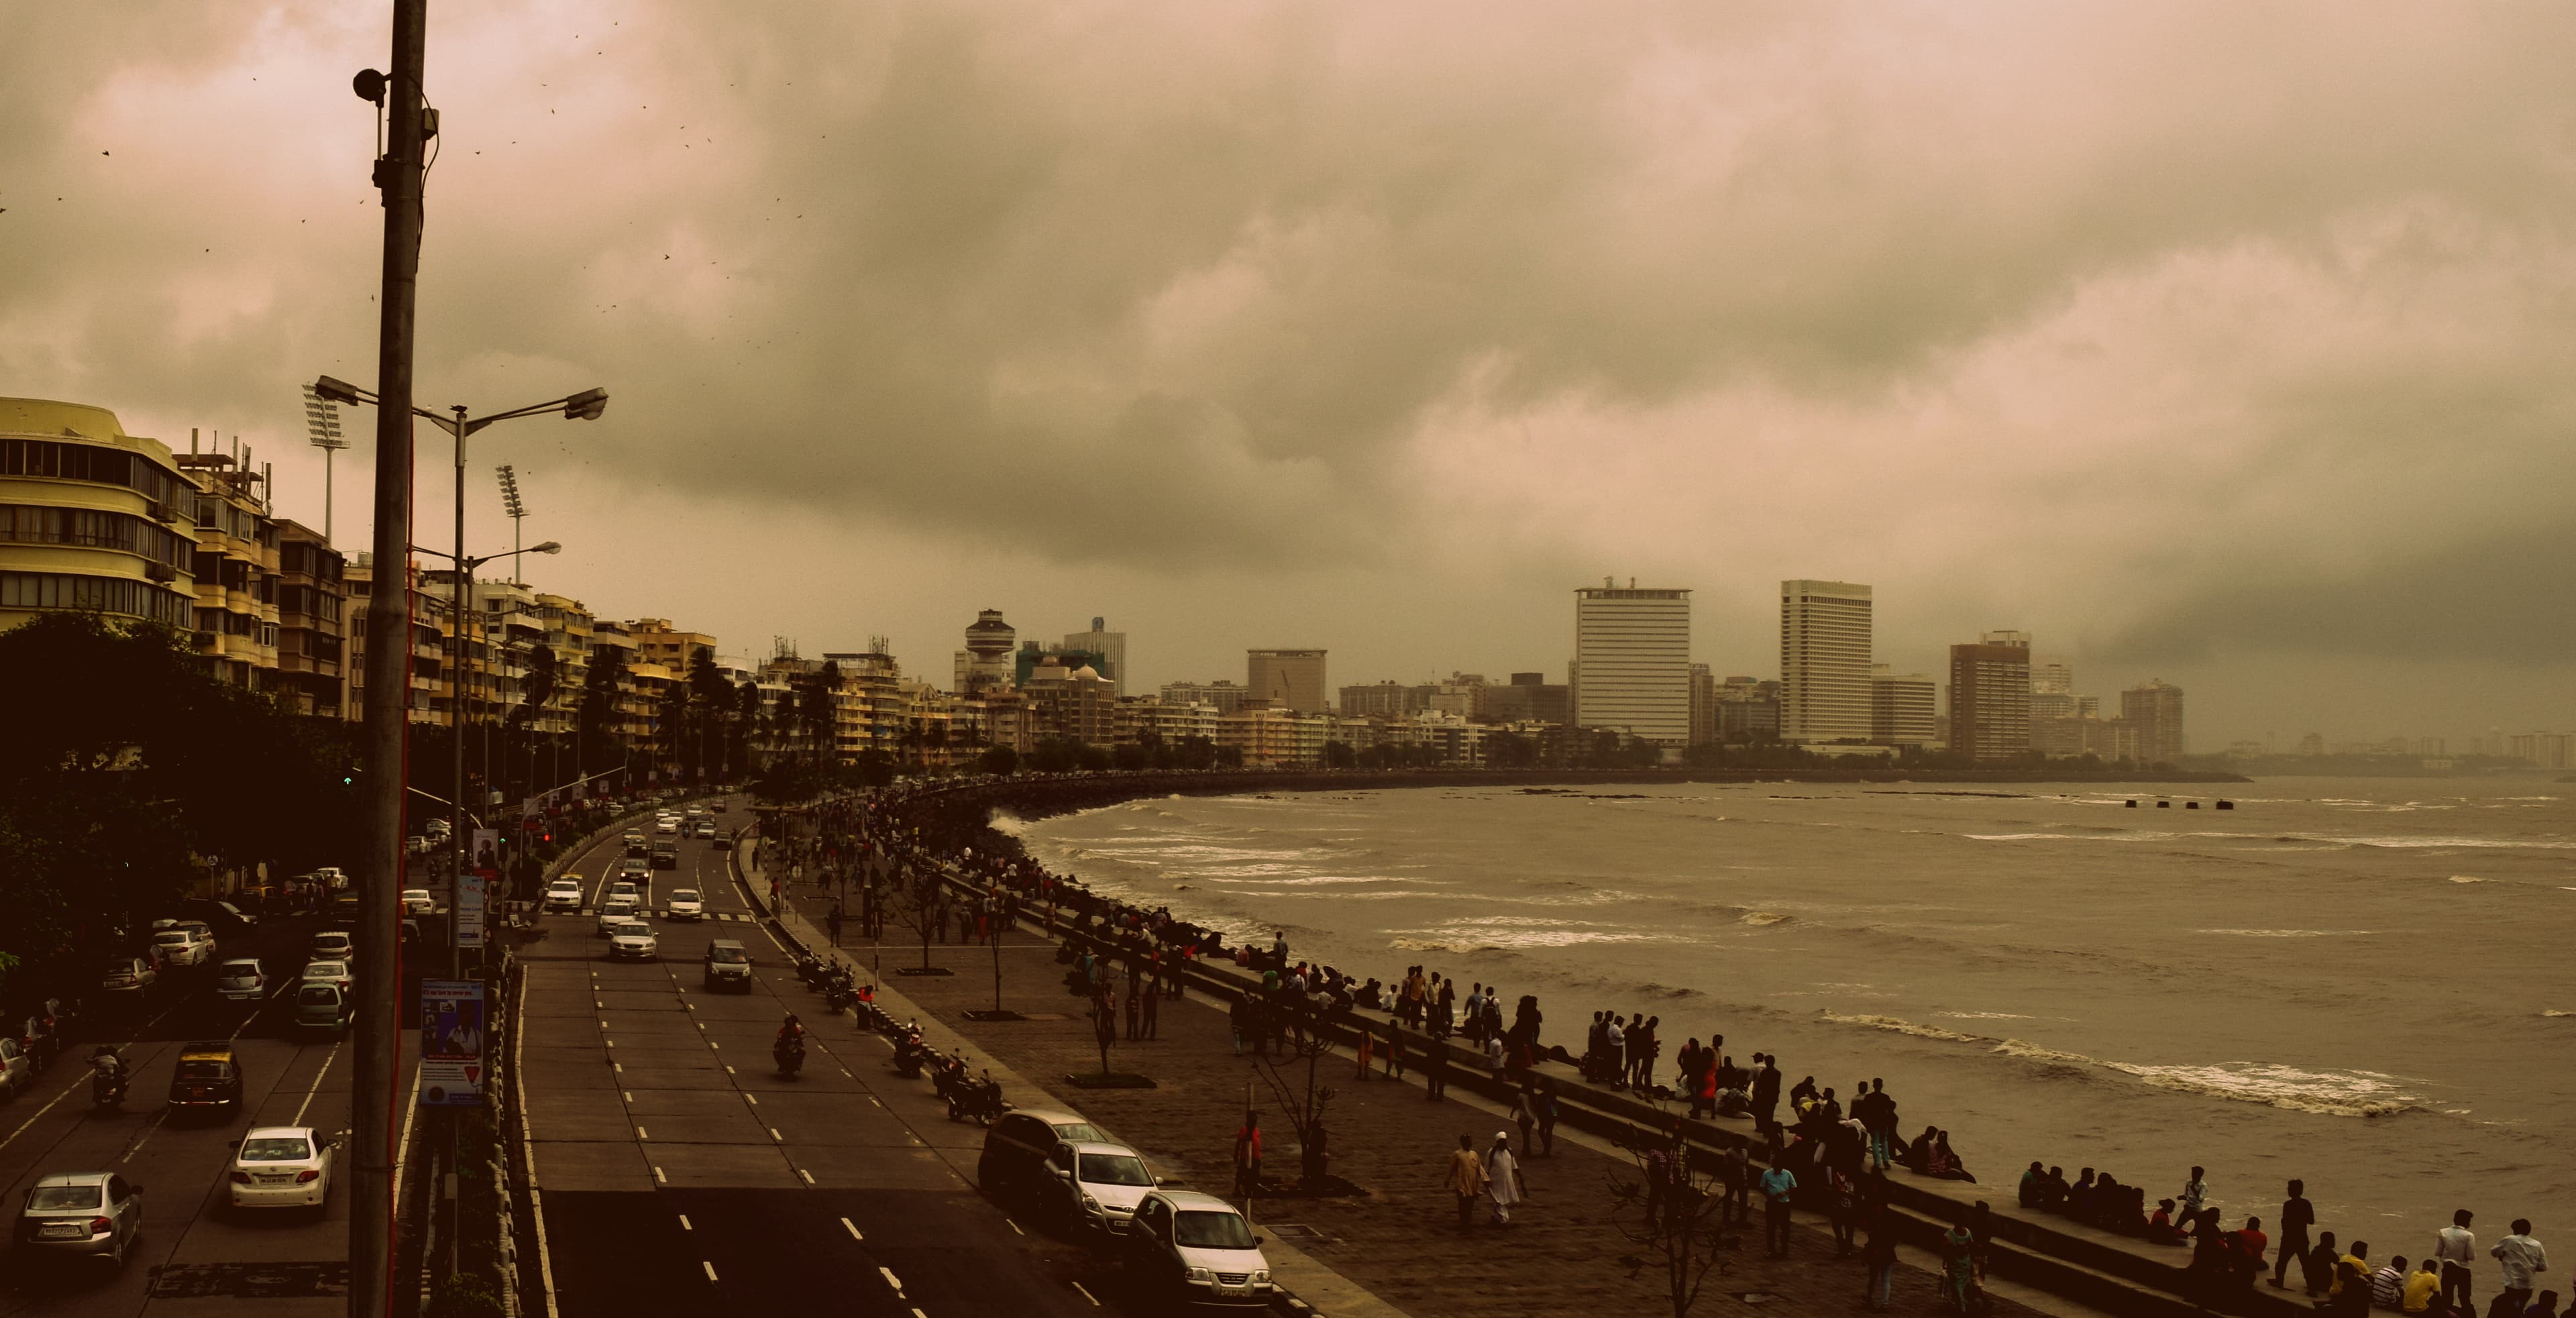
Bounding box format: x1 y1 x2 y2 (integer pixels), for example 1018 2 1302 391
767 793 2558 1318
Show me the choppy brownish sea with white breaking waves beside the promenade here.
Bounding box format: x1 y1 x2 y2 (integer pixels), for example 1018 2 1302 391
997 775 2576 1259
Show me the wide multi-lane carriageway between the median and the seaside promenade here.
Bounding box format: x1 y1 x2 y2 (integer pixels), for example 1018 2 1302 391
521 801 1116 1318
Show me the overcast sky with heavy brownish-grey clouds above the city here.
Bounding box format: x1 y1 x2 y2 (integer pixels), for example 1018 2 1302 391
0 0 2576 749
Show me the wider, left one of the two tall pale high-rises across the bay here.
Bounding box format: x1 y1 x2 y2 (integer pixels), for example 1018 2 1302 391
1571 577 1690 747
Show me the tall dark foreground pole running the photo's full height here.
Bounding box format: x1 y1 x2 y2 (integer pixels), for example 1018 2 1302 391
347 0 430 1318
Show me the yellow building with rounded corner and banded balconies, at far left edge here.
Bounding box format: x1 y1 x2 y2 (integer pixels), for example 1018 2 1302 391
0 399 199 630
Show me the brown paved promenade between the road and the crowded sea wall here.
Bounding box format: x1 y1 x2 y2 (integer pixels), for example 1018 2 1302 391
794 891 2084 1318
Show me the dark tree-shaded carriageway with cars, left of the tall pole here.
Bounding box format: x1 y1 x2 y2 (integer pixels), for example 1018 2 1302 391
0 901 410 1318
